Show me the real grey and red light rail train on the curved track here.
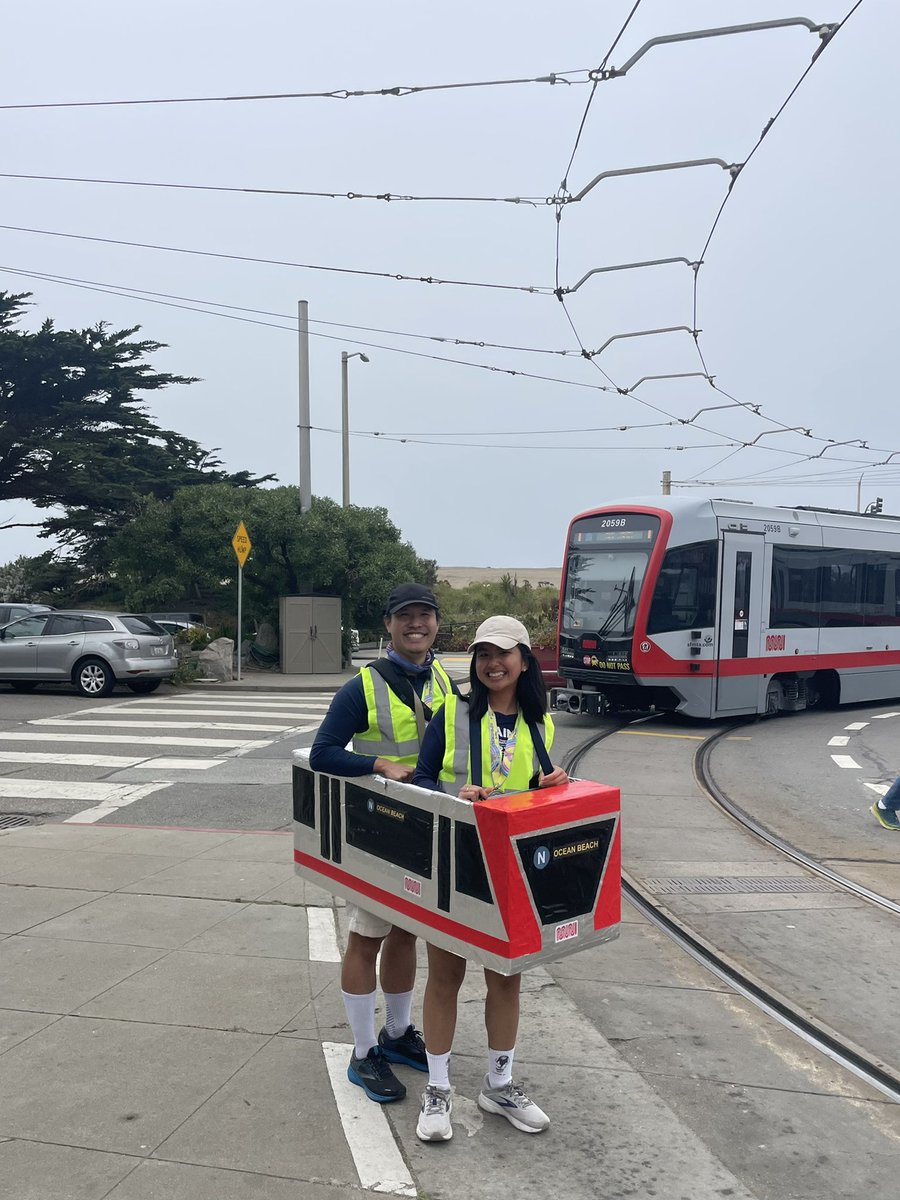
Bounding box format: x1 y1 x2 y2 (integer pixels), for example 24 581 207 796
551 497 900 719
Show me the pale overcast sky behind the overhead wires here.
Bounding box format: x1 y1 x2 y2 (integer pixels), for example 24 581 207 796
0 0 900 566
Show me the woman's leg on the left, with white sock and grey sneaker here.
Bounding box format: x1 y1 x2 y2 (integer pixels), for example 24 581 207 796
415 946 466 1141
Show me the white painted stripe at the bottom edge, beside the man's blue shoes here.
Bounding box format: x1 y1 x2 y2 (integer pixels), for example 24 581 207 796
322 1042 416 1196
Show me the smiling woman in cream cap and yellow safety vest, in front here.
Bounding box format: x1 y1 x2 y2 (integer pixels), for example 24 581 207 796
413 617 569 1141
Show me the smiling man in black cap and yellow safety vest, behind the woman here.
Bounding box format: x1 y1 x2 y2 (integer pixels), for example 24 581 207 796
310 583 456 1104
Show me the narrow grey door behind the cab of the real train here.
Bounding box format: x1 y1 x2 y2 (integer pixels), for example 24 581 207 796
715 530 766 716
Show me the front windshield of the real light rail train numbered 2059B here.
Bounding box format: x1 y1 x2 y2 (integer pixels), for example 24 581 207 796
562 512 660 637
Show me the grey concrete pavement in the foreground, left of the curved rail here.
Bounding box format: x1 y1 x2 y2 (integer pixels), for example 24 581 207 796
0 824 763 1200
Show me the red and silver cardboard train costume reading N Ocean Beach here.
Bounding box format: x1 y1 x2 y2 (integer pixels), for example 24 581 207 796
293 750 622 976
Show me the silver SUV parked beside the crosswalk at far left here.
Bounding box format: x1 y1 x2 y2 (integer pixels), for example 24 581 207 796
0 611 178 696
